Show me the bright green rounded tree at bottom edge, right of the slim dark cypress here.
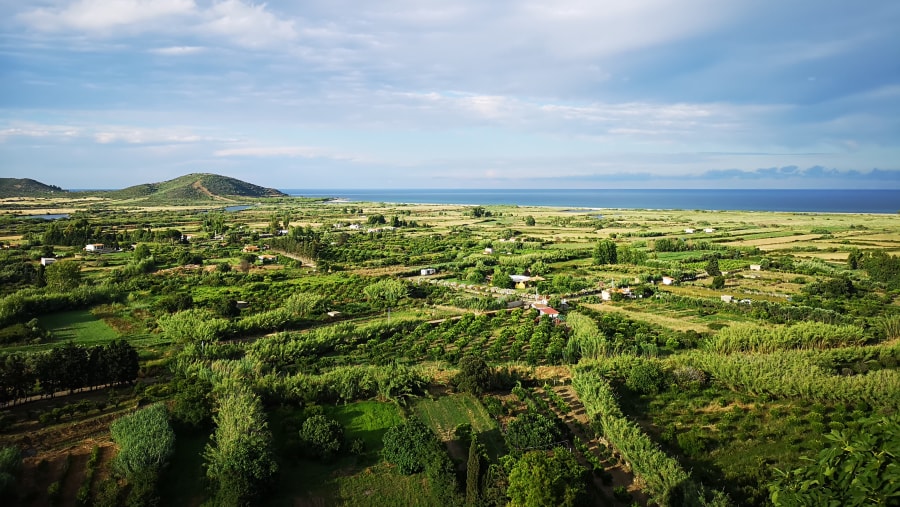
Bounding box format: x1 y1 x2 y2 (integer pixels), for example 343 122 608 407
506 448 586 507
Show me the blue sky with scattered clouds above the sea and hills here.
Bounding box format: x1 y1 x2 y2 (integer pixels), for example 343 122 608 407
0 0 900 189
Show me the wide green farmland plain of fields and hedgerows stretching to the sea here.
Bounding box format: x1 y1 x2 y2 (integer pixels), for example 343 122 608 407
0 194 900 506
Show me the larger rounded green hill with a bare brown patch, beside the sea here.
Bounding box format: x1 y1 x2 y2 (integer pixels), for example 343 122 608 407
104 173 286 202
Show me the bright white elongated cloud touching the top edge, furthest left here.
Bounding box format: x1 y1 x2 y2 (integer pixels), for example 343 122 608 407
20 0 196 32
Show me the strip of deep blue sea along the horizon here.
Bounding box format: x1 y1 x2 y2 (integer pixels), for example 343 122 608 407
282 189 900 214
